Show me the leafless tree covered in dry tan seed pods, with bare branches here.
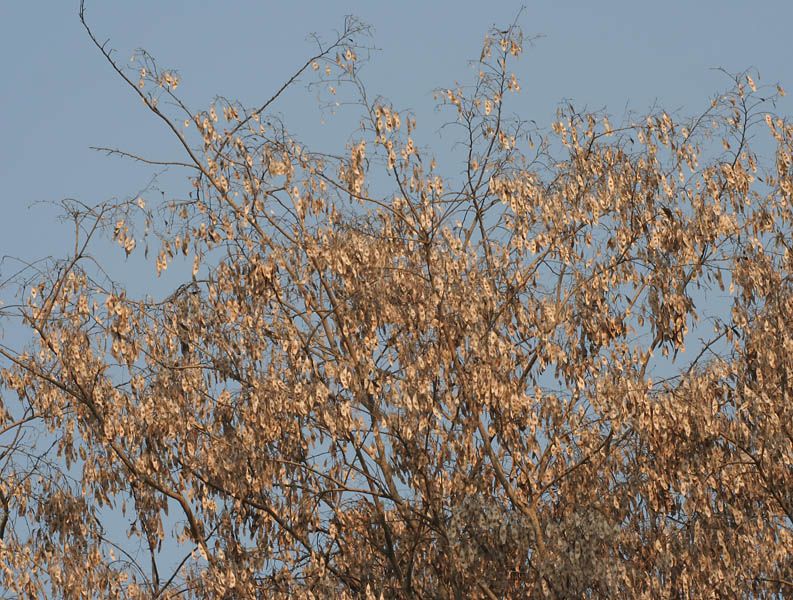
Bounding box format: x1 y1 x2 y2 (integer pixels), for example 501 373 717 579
0 4 793 598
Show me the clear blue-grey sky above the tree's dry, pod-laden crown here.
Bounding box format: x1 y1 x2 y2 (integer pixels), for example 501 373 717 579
0 0 793 274
